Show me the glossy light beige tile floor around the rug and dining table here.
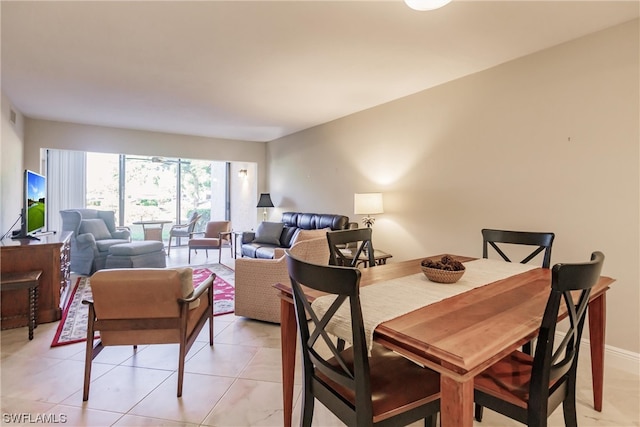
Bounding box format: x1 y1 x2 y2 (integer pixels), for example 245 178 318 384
0 248 640 427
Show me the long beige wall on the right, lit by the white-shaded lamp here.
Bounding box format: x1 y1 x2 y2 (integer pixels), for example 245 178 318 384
268 20 640 353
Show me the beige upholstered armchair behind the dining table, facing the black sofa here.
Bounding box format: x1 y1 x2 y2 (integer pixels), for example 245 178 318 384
235 237 329 323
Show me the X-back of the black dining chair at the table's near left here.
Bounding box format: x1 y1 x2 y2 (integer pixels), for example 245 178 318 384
286 250 373 425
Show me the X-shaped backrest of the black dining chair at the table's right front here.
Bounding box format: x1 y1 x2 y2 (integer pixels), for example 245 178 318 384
528 252 604 425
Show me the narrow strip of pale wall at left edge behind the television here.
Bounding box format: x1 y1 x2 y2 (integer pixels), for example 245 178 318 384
0 93 25 236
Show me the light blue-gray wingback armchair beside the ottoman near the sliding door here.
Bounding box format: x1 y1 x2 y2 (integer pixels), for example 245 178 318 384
60 209 131 276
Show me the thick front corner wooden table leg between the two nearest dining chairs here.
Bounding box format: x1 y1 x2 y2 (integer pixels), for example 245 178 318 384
440 375 473 427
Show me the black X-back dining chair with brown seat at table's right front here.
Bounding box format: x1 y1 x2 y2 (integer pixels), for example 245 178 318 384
474 252 604 427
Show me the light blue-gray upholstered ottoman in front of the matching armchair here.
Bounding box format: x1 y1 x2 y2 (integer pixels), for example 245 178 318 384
105 240 167 268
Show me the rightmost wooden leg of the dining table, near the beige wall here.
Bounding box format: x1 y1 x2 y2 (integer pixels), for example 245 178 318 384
588 293 607 412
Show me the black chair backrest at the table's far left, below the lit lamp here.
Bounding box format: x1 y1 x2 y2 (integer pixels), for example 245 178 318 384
327 227 376 267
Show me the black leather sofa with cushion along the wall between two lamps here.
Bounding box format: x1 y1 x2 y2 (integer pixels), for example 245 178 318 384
240 212 358 259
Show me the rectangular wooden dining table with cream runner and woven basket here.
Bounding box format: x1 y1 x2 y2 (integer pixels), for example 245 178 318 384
274 255 614 427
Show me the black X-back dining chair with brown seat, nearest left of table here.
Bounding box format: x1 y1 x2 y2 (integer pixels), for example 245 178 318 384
287 251 440 427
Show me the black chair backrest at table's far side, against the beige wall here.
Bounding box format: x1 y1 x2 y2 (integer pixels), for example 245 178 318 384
482 228 555 268
